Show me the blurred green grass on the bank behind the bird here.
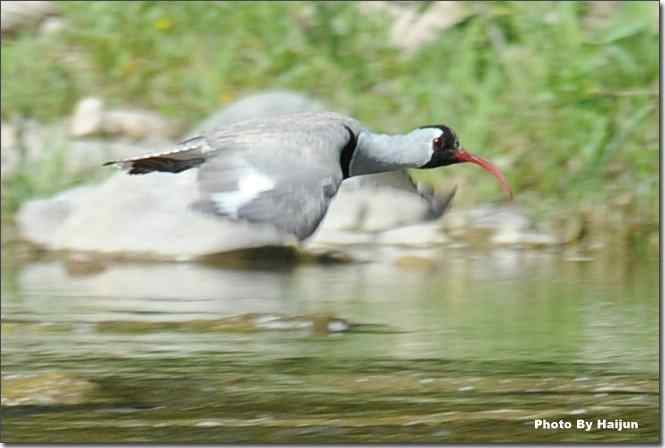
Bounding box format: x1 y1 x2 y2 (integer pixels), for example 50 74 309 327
1 2 659 222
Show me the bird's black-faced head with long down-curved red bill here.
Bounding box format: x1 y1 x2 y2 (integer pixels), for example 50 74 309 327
412 125 513 199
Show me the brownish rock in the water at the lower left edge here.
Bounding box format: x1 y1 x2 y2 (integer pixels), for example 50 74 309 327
2 372 103 406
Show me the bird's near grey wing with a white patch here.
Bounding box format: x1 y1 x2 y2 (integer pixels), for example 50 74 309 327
195 123 350 240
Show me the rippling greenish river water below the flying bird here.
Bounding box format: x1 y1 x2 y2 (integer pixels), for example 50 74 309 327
2 242 660 443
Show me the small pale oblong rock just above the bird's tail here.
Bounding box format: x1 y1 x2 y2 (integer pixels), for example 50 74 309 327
69 98 178 140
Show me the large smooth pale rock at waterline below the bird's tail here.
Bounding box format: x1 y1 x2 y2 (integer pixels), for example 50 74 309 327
16 171 290 260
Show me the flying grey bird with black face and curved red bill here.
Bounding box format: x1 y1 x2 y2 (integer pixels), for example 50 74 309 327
104 112 513 241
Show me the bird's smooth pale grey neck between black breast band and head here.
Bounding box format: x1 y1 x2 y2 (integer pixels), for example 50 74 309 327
349 132 429 176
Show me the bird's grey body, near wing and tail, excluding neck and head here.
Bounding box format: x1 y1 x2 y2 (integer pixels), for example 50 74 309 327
109 112 364 240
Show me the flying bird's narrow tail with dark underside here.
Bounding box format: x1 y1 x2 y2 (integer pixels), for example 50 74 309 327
104 137 211 174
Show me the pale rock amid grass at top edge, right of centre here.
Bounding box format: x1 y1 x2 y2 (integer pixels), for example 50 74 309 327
360 1 470 54
